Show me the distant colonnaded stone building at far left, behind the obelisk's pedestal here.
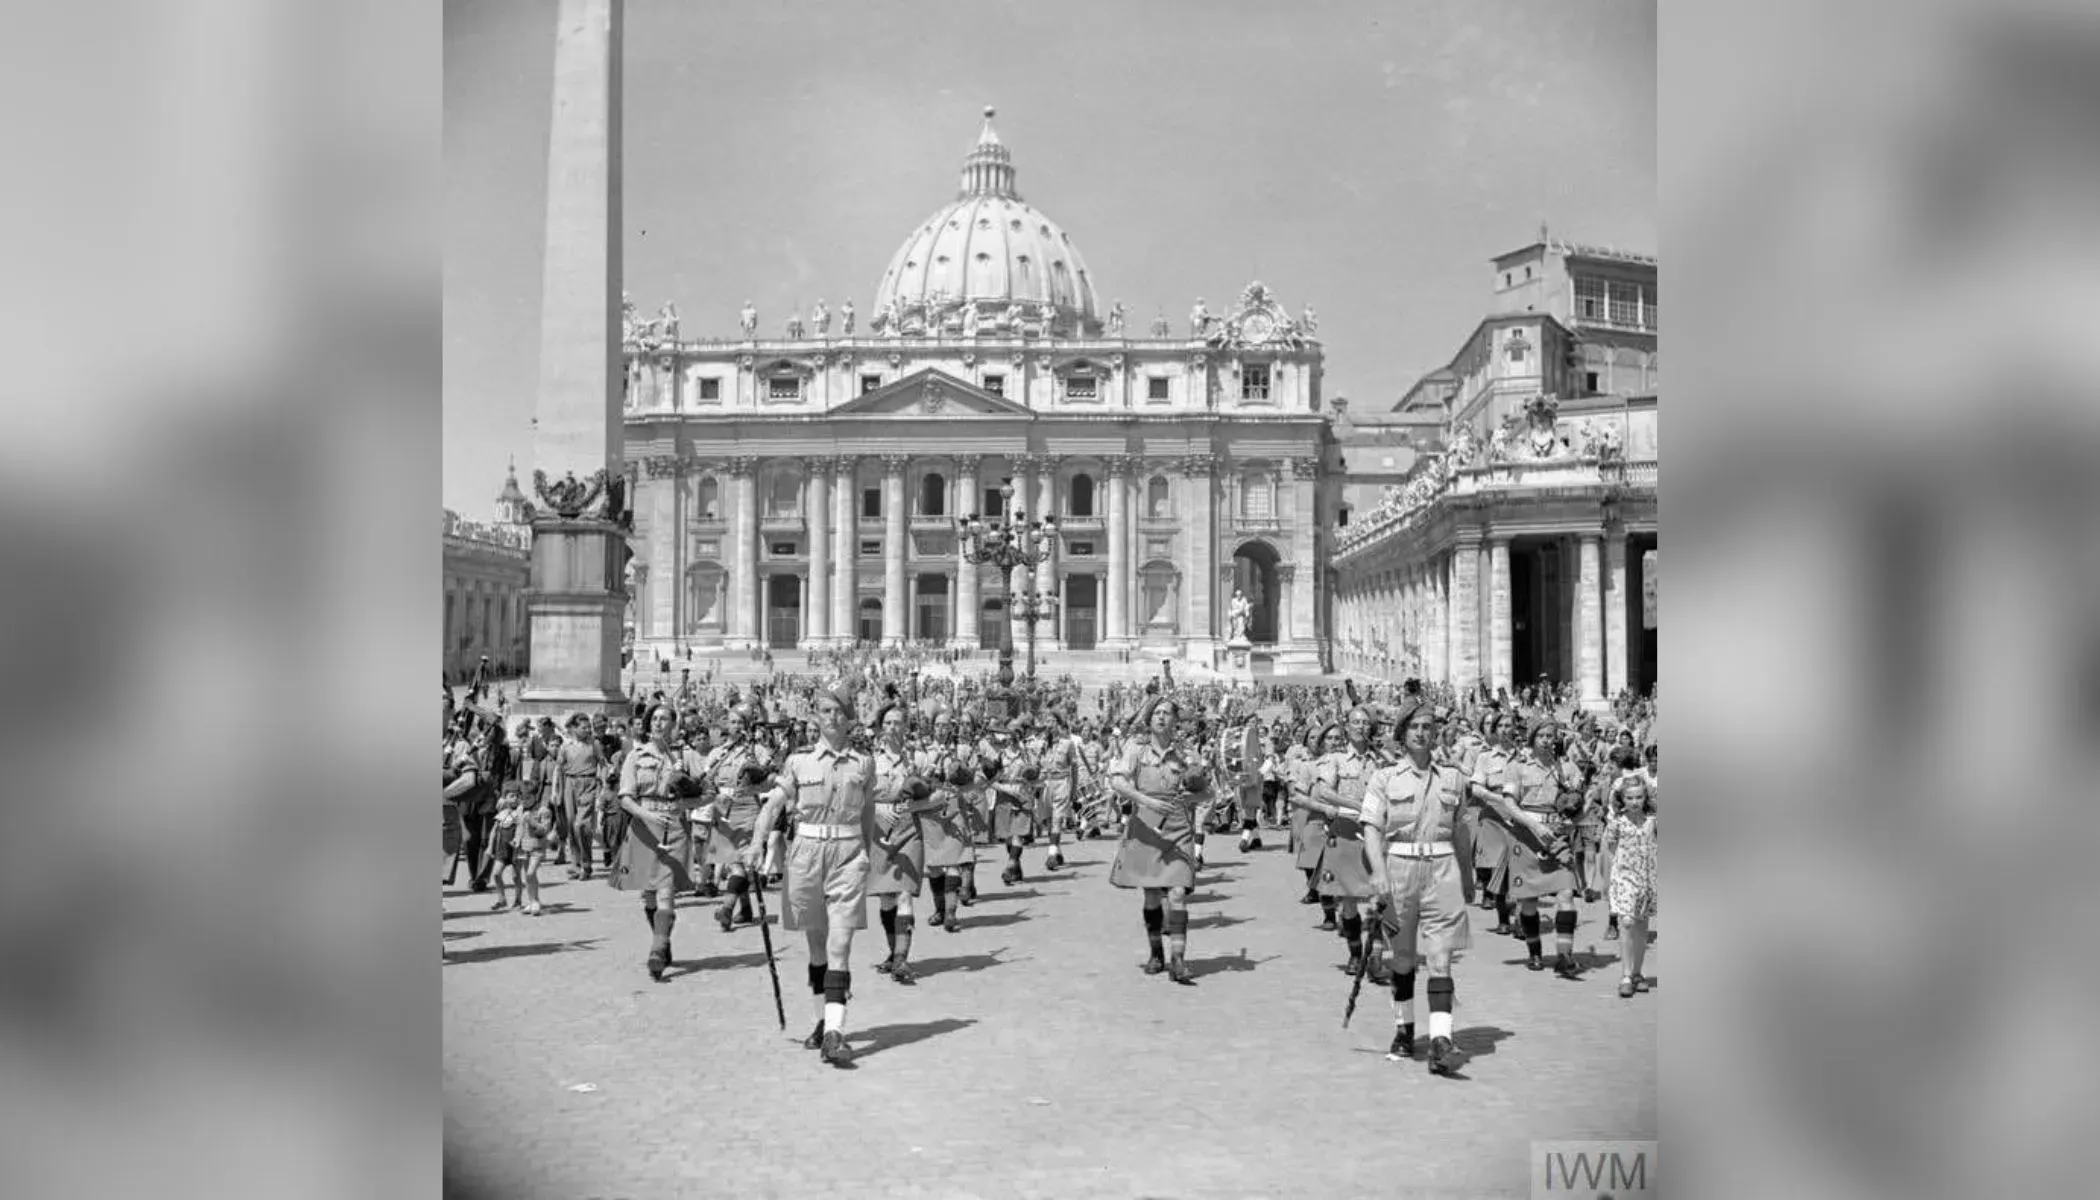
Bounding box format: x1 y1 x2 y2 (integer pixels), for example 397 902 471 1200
443 467 531 683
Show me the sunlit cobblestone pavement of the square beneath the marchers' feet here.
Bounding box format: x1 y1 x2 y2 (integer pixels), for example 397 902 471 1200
443 834 1667 1198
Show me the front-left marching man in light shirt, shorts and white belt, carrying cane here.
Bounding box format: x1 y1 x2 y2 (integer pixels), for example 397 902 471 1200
743 691 876 1068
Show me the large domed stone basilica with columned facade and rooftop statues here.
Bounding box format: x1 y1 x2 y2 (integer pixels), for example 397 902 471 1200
626 109 1331 670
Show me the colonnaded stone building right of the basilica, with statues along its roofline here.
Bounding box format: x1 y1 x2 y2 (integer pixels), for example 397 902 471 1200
1329 229 1659 704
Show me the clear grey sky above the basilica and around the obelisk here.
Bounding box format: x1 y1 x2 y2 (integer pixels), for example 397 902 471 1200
443 0 1657 519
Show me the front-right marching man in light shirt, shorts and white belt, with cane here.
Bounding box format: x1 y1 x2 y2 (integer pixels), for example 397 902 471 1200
1363 702 1535 1074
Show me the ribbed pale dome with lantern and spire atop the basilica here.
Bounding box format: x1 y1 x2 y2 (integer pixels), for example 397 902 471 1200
874 109 1103 334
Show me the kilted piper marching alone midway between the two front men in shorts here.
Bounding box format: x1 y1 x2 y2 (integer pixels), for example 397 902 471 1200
1109 696 1210 984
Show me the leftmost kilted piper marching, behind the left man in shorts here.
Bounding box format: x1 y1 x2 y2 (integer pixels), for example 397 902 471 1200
611 704 704 979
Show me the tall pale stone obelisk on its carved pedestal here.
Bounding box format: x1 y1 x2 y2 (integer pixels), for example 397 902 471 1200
519 0 628 715
